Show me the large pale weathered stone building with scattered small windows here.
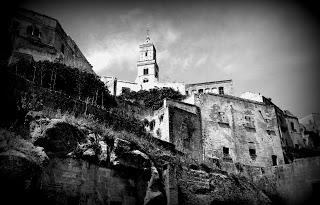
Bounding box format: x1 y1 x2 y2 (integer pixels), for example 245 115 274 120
186 93 284 167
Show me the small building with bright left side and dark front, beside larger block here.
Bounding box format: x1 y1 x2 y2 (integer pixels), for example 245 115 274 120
145 100 203 160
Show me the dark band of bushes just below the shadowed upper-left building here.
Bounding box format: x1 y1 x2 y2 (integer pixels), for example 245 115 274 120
10 60 115 107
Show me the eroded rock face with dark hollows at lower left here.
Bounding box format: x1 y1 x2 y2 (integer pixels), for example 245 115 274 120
0 113 166 205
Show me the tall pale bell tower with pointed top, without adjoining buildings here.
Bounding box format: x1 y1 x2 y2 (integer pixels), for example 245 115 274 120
135 31 159 85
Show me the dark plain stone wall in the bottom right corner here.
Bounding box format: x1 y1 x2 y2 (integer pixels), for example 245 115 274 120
252 157 320 204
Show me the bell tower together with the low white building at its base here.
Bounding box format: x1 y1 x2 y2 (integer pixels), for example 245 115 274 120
101 36 185 95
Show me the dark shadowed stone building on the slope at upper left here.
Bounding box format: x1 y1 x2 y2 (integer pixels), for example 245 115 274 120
8 9 94 73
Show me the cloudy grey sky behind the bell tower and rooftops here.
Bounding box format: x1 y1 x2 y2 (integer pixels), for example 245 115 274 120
16 0 320 117
